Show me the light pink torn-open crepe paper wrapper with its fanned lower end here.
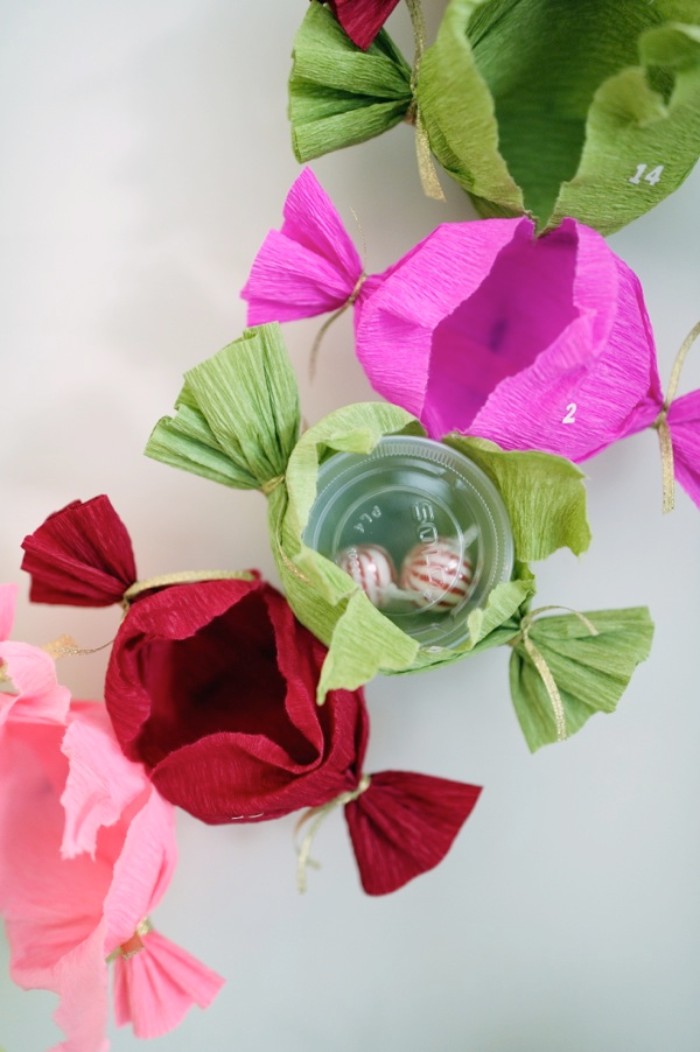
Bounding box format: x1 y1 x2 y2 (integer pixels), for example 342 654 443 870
0 669 222 1052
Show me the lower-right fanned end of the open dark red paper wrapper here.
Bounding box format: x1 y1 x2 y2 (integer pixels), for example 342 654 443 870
345 771 481 895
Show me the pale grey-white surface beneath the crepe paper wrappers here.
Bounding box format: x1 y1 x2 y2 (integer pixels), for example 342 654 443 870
0 0 700 1052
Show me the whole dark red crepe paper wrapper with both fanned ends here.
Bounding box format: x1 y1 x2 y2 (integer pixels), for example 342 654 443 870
23 497 481 895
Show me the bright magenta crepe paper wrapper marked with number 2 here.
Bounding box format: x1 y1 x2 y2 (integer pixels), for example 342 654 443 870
242 168 700 504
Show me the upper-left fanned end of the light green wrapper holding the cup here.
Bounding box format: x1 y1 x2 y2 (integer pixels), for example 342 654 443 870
145 323 299 489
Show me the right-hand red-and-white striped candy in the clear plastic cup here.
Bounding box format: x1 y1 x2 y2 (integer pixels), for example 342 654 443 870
400 538 474 612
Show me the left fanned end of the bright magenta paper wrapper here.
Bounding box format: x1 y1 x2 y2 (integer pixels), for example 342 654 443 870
241 168 362 325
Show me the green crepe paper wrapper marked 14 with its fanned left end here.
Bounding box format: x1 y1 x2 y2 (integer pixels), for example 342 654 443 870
289 0 700 234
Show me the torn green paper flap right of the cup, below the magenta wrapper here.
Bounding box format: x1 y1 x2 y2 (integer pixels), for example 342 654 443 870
443 433 591 562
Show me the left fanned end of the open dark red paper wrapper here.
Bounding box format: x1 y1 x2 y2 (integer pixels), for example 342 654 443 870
22 497 136 606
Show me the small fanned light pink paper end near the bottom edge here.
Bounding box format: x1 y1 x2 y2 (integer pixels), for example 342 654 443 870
114 931 224 1038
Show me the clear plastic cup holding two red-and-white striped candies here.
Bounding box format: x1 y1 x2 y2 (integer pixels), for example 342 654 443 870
303 436 514 648
